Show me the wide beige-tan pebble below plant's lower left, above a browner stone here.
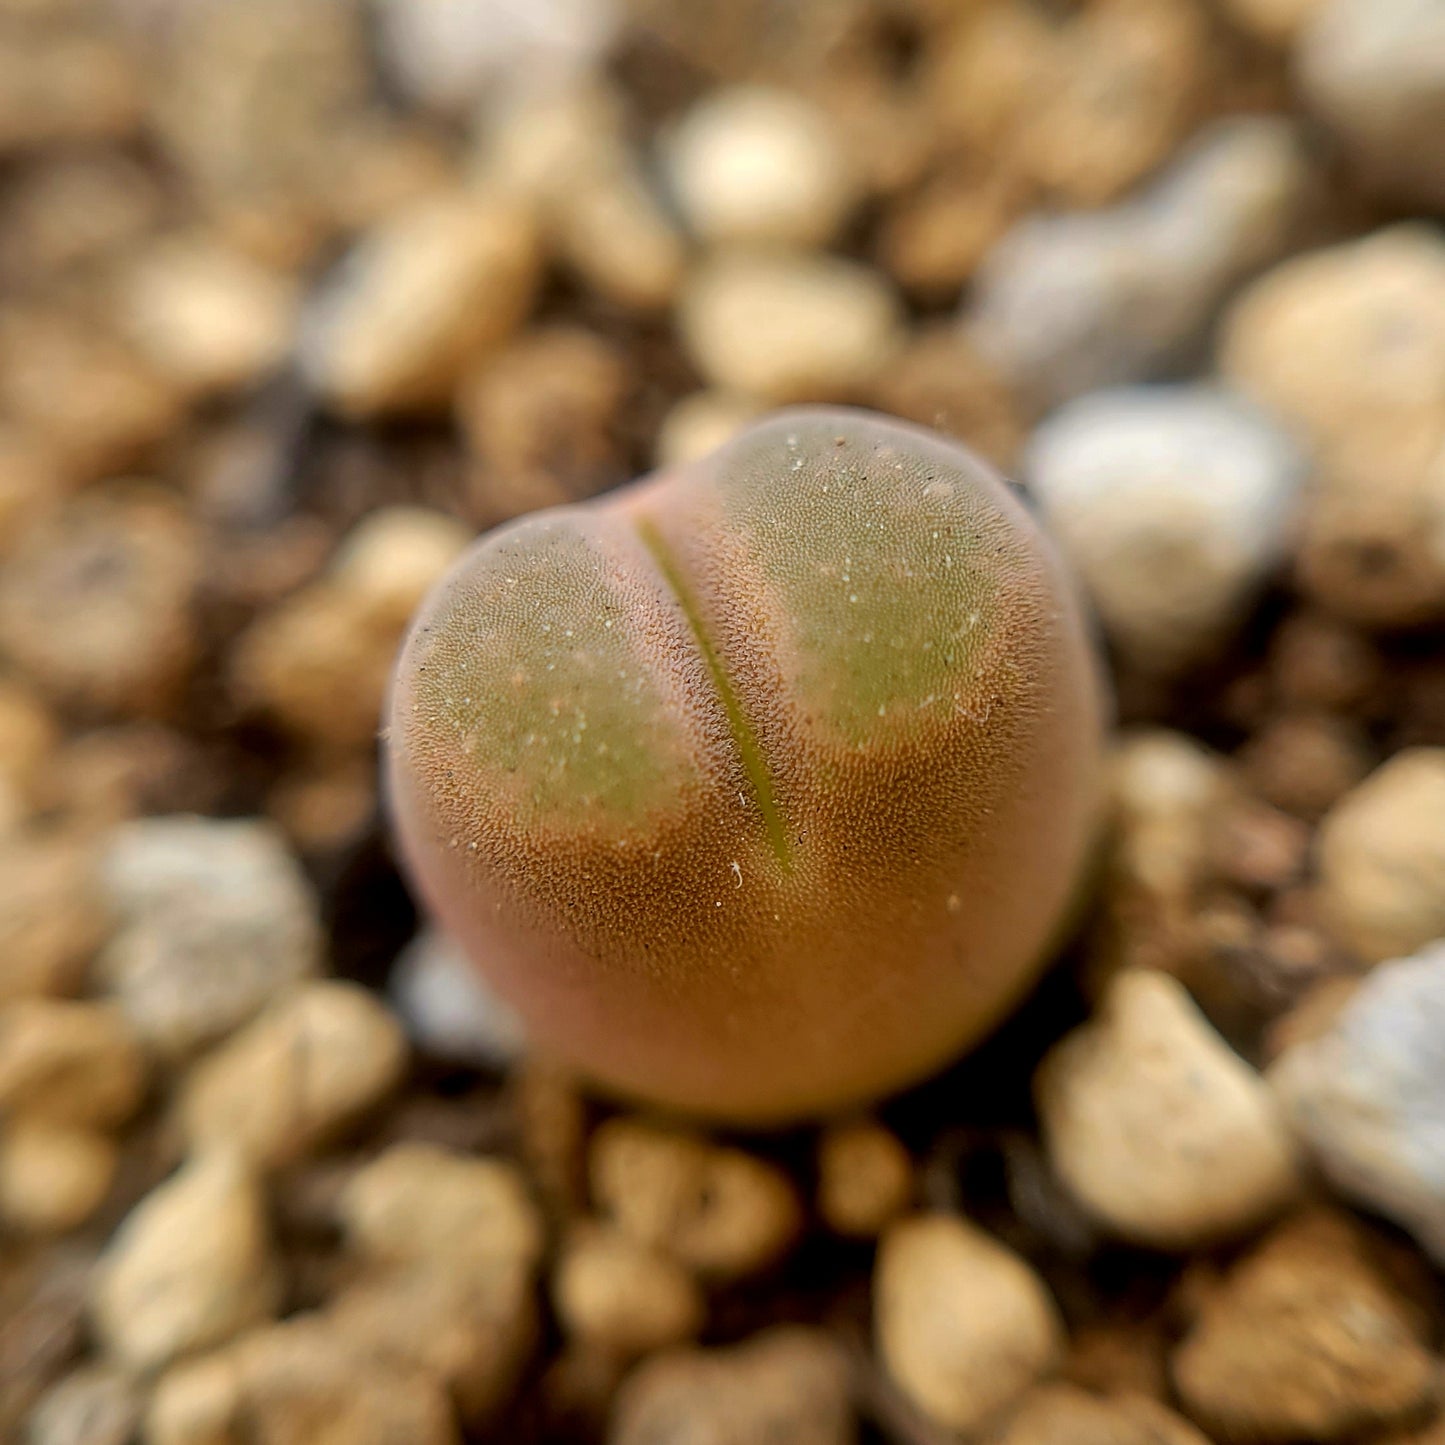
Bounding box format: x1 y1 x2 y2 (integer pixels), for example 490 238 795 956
341 1143 543 1269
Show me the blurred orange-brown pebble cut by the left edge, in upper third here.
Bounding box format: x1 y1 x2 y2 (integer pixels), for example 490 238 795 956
0 306 185 483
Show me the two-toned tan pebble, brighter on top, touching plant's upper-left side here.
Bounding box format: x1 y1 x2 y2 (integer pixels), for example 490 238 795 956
230 507 473 764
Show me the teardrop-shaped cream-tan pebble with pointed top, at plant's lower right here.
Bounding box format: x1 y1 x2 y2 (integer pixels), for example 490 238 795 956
1035 971 1301 1250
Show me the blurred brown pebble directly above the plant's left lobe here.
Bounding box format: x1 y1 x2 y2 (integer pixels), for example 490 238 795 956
457 327 633 525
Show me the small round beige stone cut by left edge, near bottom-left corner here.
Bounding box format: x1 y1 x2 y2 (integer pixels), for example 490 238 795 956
0 1120 120 1234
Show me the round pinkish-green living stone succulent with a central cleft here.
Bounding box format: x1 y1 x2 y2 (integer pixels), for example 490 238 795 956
389 409 1103 1123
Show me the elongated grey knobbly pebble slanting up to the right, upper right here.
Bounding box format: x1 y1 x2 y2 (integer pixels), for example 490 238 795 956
964 117 1309 407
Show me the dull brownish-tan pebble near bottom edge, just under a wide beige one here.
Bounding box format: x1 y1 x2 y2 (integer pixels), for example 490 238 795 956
322 1259 538 1425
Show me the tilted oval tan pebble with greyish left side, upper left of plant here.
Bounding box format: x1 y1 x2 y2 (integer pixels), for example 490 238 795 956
298 194 540 419
